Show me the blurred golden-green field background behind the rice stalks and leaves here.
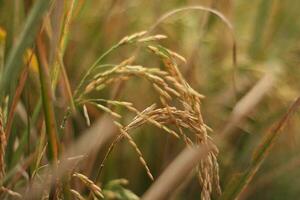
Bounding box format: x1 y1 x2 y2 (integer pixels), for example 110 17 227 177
0 0 300 200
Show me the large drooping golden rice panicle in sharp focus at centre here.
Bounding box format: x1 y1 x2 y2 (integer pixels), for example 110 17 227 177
75 32 221 199
